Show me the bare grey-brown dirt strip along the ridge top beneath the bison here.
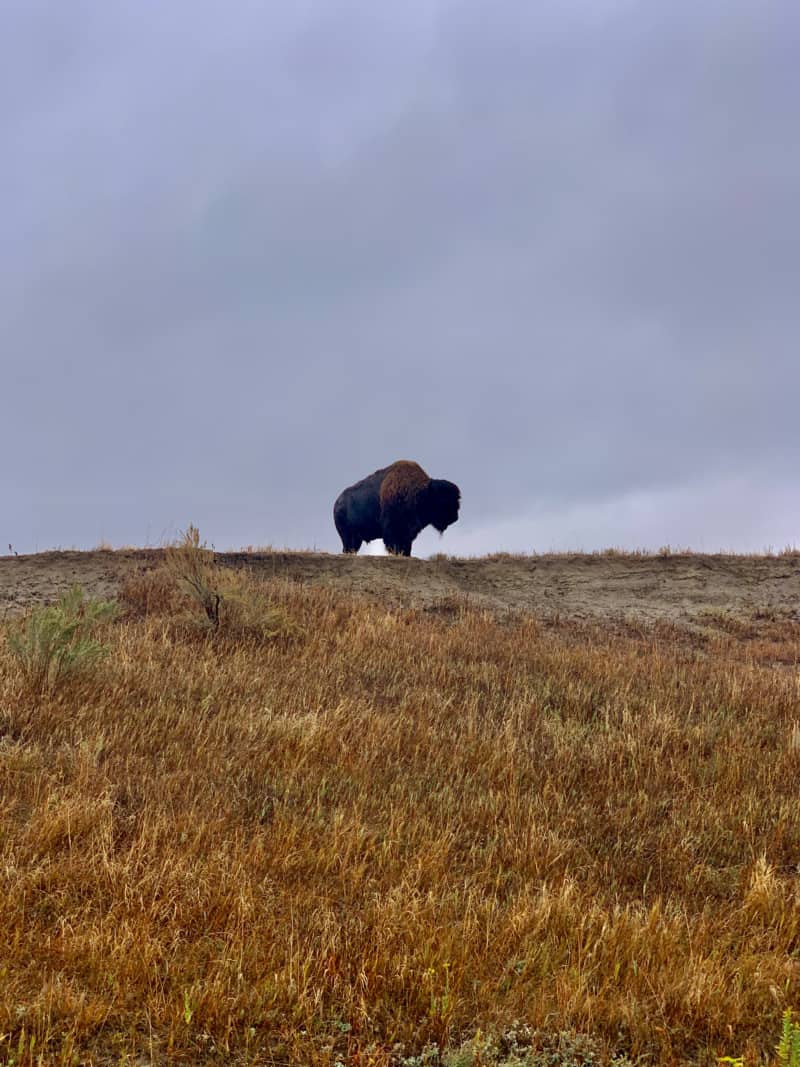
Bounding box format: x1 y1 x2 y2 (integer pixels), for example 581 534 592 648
0 550 800 624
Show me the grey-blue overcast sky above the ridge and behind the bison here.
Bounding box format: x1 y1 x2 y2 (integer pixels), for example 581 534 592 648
0 0 800 555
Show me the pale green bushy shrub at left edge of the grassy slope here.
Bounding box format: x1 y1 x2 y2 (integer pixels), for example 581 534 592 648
6 586 116 692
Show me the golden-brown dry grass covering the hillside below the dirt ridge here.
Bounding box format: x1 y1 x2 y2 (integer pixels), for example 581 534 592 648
0 572 800 1065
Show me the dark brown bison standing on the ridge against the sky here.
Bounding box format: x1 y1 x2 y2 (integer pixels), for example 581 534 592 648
334 460 461 556
